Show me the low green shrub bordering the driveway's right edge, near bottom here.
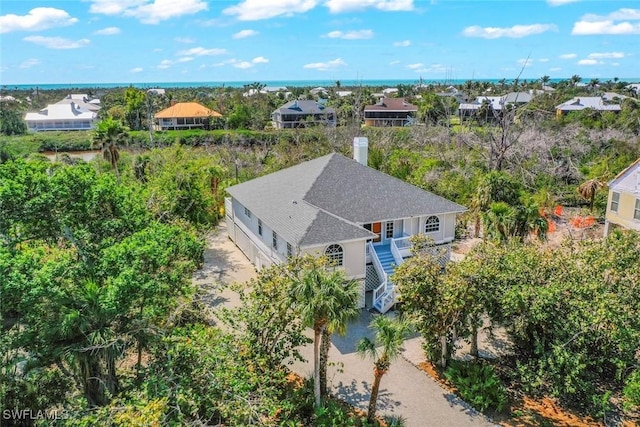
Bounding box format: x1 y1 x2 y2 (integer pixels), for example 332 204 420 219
444 361 507 412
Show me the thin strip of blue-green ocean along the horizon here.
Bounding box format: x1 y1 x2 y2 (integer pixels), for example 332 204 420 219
0 78 640 90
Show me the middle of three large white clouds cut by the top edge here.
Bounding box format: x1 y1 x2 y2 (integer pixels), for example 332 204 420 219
222 0 318 21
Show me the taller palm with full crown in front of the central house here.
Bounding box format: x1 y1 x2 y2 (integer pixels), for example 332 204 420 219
293 256 358 407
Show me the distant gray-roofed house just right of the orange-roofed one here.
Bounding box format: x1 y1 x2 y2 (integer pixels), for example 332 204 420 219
271 100 336 129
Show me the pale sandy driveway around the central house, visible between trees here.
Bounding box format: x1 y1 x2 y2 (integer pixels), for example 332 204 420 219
194 224 494 427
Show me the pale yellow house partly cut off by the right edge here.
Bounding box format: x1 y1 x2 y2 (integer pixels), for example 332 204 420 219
604 159 640 236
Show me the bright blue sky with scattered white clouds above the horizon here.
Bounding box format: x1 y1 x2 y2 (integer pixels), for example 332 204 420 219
0 0 640 85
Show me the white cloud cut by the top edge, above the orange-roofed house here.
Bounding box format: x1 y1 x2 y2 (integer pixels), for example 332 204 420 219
89 0 209 24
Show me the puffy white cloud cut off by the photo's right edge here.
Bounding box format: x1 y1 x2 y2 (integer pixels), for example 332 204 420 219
571 8 640 36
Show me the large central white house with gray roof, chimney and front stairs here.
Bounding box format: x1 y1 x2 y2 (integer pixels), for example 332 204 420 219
225 137 466 313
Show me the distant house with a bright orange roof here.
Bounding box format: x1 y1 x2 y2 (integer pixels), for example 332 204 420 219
154 102 222 130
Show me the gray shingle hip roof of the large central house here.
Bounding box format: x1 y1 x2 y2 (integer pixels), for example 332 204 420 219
227 153 466 246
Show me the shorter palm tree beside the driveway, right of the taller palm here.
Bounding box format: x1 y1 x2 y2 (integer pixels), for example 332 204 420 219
358 315 409 423
